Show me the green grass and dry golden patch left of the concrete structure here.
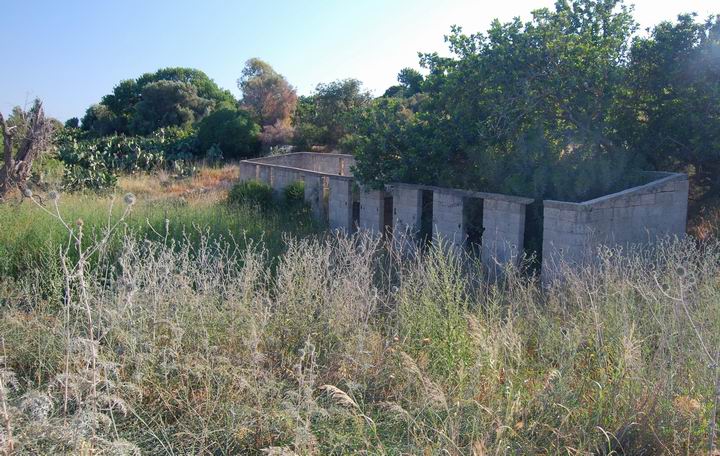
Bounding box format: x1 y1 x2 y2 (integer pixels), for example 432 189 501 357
0 166 318 277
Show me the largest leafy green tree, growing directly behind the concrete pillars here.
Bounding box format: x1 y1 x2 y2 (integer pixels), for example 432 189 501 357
357 0 636 199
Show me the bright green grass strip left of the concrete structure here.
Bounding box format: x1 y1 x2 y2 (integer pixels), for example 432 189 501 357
0 189 320 277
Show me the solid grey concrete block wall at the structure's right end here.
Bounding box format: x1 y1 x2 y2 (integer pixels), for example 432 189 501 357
542 173 688 280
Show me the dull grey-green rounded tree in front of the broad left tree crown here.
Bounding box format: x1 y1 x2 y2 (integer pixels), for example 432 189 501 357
130 80 212 135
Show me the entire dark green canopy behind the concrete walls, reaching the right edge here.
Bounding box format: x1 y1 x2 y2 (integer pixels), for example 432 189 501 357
350 0 720 200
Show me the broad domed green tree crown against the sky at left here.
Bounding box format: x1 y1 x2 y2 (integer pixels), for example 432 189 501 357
82 68 235 136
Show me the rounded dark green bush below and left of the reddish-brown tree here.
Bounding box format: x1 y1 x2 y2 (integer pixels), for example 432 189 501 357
198 108 260 159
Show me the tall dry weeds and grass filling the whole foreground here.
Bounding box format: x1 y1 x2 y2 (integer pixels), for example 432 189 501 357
0 201 720 455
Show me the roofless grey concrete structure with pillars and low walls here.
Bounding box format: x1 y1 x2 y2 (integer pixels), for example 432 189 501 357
240 152 688 278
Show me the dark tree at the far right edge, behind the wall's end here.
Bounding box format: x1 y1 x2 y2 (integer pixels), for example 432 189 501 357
617 14 720 199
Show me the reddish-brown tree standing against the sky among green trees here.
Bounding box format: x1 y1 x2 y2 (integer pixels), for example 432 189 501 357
238 58 297 126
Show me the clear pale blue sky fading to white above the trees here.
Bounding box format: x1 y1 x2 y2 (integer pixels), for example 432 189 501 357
0 0 720 120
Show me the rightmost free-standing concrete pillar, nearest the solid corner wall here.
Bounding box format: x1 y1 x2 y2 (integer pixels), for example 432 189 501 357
482 199 526 277
